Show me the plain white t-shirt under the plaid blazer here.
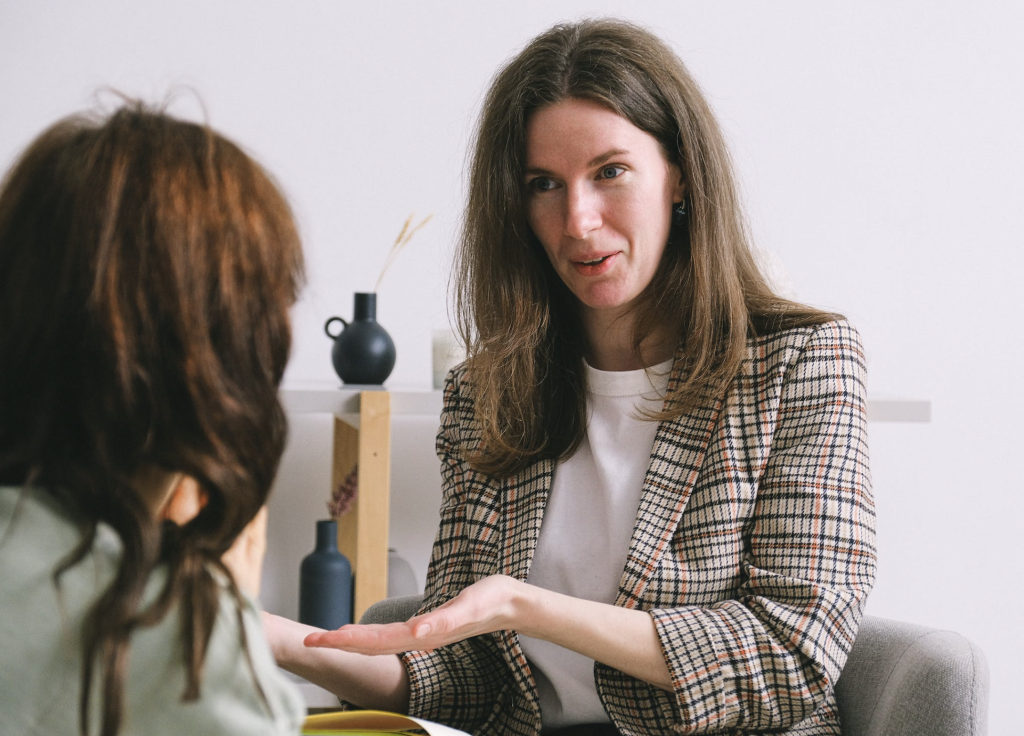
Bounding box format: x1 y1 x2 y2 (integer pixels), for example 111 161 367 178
519 360 672 728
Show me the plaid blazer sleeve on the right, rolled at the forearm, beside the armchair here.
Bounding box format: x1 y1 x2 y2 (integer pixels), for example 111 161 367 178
651 322 876 733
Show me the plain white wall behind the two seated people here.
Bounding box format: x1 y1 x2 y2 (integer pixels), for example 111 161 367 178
0 0 1024 734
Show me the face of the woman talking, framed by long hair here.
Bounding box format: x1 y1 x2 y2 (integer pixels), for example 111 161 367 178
525 98 684 319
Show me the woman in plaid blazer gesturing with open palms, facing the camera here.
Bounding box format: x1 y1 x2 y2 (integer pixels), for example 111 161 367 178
268 20 874 734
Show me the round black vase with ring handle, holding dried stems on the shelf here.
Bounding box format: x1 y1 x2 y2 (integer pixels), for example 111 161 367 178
324 293 395 386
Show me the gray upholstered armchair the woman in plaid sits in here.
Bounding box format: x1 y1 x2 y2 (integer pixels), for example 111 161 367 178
360 596 988 736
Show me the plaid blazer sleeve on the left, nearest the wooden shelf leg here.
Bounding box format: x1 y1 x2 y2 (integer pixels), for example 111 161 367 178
402 369 515 732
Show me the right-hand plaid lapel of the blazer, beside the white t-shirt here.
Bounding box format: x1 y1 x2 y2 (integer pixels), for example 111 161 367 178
615 351 725 608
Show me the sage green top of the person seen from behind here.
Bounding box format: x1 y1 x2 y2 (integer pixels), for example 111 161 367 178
0 487 305 736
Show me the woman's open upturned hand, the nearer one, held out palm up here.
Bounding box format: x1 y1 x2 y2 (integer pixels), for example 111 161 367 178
304 575 520 654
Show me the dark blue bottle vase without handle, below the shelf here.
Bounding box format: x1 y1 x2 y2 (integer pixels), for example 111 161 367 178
299 519 352 629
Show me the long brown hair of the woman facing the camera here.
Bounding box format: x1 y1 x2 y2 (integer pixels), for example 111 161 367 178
455 19 831 475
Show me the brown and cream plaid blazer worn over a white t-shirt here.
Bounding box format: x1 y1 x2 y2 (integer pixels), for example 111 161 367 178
403 321 876 735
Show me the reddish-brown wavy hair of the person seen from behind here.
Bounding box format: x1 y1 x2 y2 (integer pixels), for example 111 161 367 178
0 102 302 736
